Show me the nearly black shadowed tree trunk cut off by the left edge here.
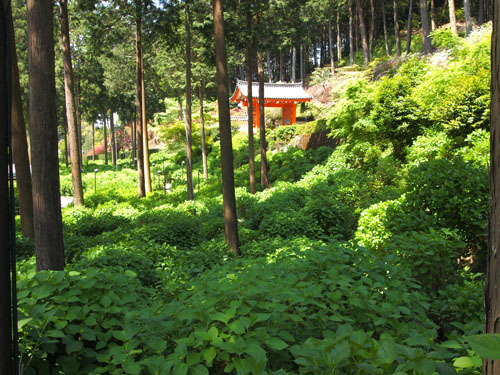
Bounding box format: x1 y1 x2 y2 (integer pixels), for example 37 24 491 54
0 0 14 375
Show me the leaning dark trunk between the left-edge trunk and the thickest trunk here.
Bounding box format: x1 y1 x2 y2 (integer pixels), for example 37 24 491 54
9 17 33 238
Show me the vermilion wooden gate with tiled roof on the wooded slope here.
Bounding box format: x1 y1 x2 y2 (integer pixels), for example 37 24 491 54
231 80 312 128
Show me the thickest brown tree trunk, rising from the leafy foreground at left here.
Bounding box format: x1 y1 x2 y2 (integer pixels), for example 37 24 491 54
27 0 64 271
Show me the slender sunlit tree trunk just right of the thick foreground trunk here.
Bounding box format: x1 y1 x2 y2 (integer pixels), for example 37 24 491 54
59 0 83 206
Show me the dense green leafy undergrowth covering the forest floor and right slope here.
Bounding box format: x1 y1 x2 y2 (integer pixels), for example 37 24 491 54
18 25 489 374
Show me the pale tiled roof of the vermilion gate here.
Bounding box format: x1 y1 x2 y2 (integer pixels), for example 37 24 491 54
231 80 312 100
